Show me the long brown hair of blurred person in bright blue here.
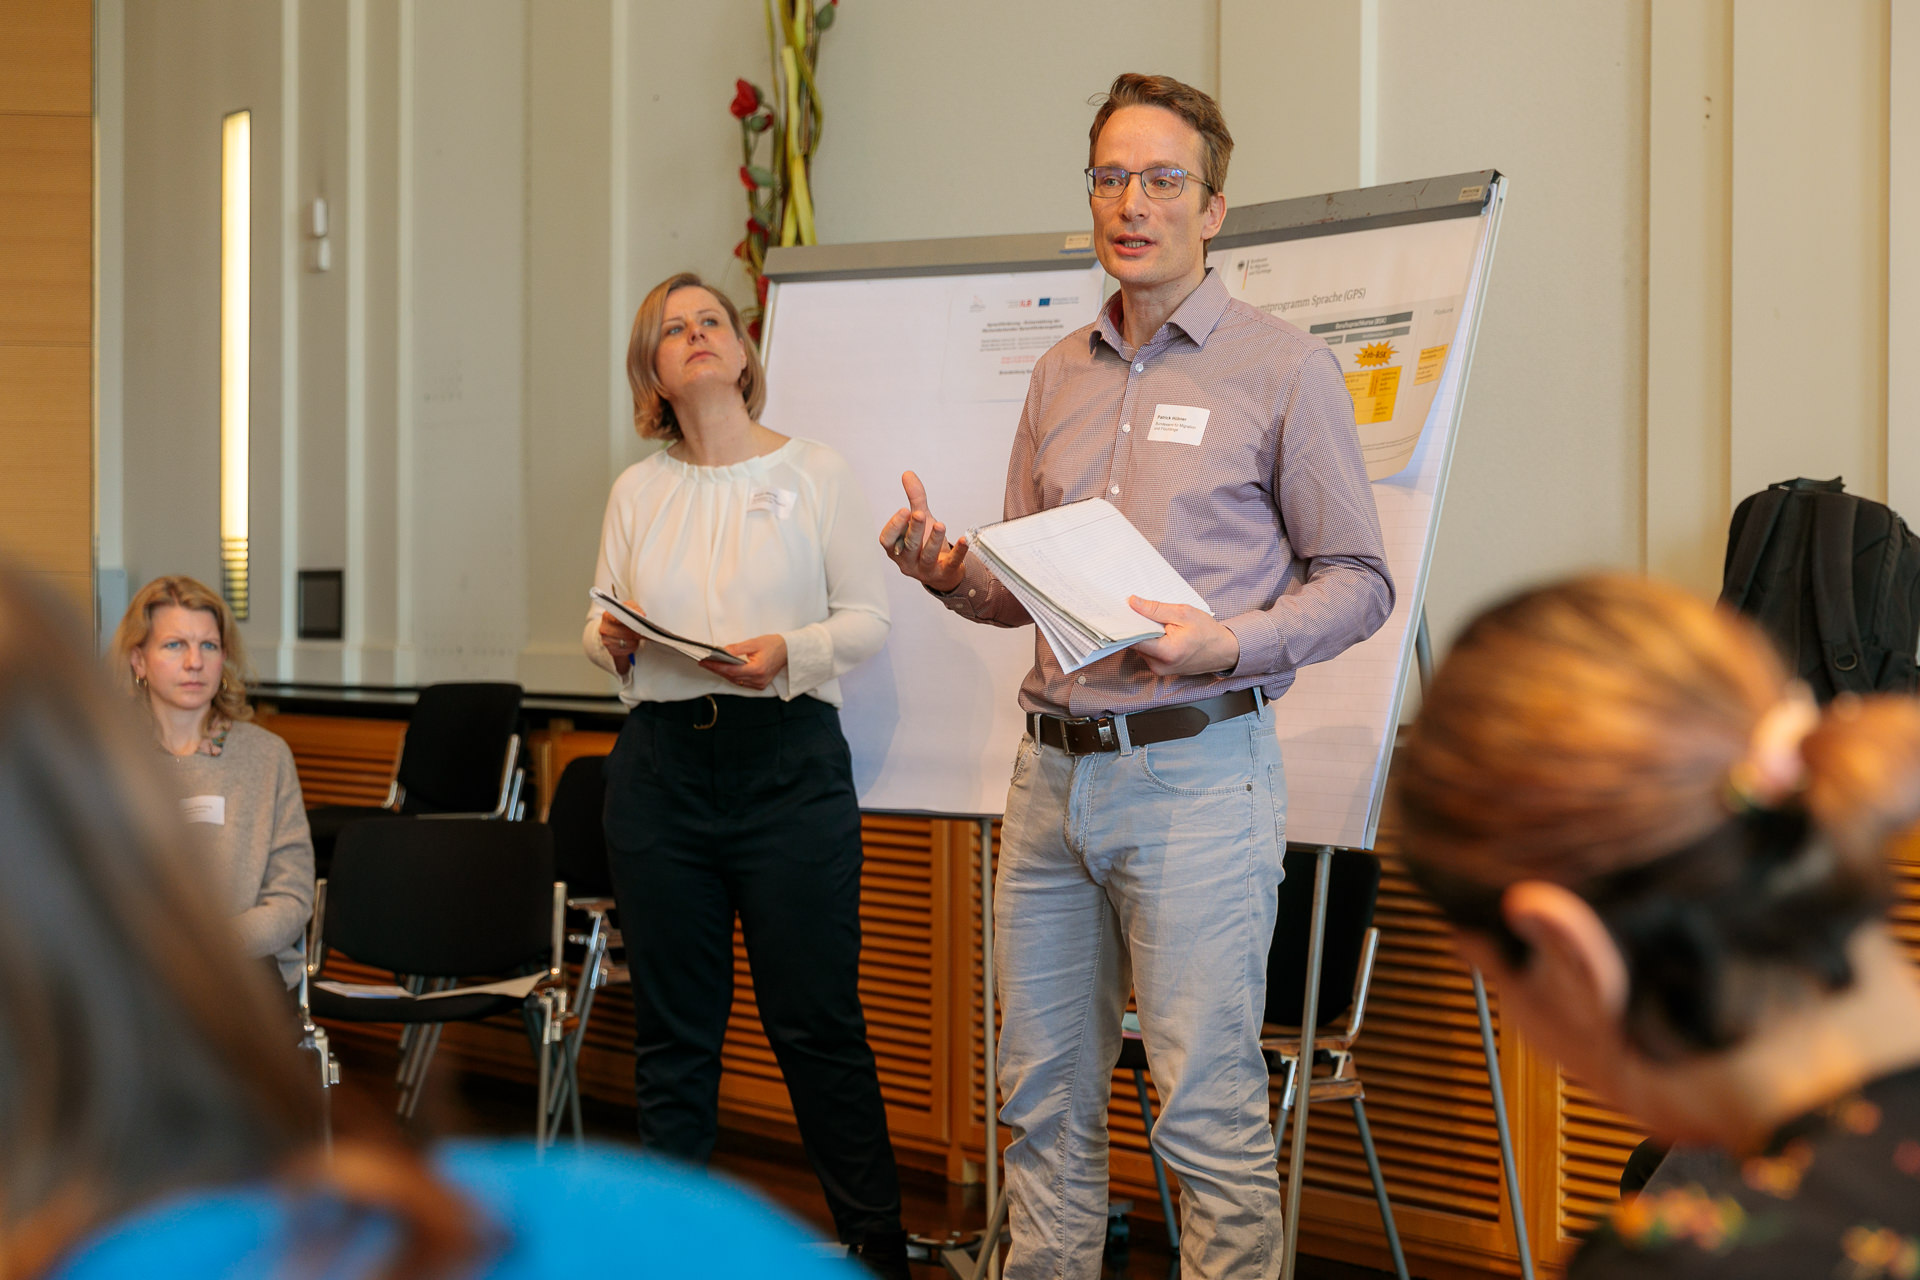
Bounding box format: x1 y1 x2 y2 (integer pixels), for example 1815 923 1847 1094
0 570 478 1278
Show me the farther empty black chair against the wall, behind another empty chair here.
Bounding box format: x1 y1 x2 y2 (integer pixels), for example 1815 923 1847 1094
307 681 524 875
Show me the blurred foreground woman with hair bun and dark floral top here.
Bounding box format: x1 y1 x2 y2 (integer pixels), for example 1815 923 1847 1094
1394 576 1920 1280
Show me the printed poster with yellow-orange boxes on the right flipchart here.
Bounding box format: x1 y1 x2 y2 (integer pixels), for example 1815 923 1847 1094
1208 219 1480 480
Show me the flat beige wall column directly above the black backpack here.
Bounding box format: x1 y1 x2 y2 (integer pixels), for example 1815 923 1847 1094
1730 0 1887 501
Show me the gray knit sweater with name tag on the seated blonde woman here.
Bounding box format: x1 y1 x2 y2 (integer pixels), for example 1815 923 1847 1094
169 720 313 986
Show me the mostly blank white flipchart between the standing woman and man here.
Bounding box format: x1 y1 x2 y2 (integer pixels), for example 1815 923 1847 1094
760 245 1104 814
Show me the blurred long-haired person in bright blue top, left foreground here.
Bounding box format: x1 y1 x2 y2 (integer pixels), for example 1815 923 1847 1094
0 570 847 1280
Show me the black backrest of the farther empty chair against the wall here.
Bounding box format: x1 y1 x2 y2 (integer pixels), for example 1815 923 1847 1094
397 683 520 814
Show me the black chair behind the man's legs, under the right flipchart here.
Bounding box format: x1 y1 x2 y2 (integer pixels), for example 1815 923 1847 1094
1116 848 1407 1280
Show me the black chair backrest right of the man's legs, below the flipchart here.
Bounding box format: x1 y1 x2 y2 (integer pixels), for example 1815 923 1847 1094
1267 848 1380 1027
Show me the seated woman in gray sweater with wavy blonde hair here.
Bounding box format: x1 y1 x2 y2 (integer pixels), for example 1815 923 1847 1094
109 578 313 988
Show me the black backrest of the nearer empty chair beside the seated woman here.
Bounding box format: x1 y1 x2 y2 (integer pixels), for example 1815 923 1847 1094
321 818 555 977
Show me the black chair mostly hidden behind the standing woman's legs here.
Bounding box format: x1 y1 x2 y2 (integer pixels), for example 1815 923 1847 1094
547 756 628 1142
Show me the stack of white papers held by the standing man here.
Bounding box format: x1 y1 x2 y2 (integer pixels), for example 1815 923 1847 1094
968 497 1213 672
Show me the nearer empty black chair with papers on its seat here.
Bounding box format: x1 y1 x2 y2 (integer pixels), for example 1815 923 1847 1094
307 818 566 1146
